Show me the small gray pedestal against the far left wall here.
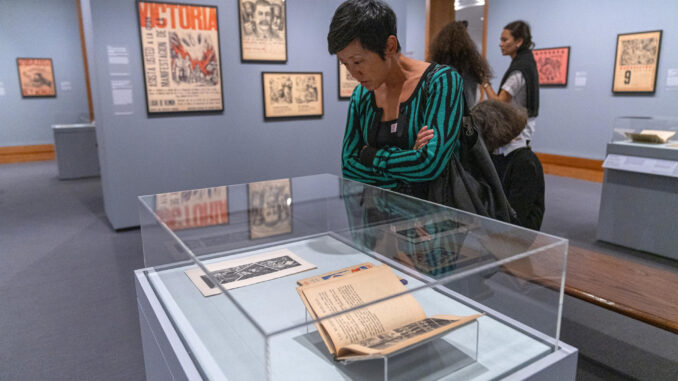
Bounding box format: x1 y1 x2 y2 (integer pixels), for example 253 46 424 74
52 124 99 180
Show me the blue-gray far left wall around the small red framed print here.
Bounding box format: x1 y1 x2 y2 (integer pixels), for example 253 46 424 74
0 0 89 147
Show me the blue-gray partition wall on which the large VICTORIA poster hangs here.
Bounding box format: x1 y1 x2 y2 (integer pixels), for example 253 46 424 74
82 0 414 229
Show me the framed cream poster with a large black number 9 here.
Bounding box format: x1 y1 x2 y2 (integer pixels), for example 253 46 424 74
612 30 662 94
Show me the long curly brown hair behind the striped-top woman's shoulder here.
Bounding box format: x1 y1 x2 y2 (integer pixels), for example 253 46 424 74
429 21 492 108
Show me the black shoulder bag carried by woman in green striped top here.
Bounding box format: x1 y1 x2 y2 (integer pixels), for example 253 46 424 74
424 65 518 224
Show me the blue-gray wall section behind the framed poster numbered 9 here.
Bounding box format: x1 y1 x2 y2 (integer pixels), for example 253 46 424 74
487 0 678 159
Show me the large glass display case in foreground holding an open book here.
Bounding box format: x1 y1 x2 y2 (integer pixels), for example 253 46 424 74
135 175 576 380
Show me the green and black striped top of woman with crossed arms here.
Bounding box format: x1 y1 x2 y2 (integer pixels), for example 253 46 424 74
341 64 463 189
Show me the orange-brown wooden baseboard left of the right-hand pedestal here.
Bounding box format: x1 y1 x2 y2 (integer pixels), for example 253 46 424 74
535 152 604 183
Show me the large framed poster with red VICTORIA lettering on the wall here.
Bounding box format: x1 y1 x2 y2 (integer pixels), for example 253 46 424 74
136 1 224 114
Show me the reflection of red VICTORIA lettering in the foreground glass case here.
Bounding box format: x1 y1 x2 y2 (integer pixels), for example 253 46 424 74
155 187 228 230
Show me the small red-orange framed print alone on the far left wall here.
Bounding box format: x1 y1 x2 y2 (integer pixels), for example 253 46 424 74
16 58 56 98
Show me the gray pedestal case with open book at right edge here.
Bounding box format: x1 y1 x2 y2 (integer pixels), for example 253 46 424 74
597 117 678 259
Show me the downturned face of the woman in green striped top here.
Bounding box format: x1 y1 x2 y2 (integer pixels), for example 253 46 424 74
337 39 389 90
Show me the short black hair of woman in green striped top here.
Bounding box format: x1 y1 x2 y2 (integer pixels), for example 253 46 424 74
327 0 400 59
